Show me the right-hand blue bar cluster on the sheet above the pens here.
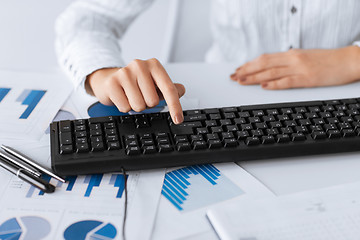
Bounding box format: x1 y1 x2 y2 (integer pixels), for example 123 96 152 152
16 89 46 119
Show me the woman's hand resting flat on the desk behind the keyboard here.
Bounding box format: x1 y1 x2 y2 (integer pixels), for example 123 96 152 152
230 46 360 90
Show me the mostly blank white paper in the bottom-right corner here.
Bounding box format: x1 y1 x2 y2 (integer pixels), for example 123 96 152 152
208 182 360 240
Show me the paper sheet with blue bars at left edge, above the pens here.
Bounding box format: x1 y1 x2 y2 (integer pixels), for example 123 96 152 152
0 71 72 140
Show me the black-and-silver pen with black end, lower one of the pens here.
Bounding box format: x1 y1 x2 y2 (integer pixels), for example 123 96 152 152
0 157 55 193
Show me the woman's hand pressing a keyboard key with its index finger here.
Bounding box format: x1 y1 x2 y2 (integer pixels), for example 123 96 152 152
85 58 185 124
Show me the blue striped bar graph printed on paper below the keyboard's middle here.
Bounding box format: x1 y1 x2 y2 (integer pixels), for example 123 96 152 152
162 164 244 211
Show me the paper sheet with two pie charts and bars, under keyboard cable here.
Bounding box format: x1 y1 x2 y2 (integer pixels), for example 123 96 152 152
0 167 163 240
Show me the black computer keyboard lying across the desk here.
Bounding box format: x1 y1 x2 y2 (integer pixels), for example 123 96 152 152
51 98 360 175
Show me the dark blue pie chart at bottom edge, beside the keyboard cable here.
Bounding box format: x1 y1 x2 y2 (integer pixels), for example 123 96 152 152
64 220 117 240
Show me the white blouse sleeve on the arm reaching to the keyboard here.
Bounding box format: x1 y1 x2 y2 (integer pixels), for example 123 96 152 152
55 0 152 86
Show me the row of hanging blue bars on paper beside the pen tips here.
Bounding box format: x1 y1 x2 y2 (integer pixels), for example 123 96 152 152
26 174 128 198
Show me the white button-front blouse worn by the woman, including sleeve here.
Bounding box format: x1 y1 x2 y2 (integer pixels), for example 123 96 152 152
56 0 360 86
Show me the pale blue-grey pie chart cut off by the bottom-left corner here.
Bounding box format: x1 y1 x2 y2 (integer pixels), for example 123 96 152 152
0 216 50 240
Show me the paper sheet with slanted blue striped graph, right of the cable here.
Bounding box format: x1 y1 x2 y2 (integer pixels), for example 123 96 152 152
152 163 273 239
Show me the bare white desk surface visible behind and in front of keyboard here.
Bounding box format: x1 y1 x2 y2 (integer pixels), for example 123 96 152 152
166 63 360 194
